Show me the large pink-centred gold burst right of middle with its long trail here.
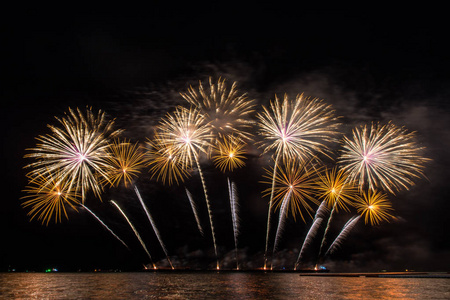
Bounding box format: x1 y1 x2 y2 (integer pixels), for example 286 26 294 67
257 94 338 268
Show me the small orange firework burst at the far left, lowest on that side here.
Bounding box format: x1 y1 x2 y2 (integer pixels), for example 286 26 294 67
22 173 80 225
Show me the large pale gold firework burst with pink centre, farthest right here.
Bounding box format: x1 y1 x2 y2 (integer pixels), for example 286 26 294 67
338 122 428 193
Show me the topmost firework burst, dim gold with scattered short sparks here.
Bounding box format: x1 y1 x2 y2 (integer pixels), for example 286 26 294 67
181 78 255 140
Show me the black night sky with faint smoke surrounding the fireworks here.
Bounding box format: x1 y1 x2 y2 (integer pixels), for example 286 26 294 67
0 3 450 271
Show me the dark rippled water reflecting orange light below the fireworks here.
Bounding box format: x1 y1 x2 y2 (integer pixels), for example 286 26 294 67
0 272 450 299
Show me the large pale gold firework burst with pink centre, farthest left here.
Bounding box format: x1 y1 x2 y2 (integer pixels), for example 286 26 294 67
25 109 121 203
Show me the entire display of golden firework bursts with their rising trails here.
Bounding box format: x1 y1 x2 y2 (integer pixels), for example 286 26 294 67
22 78 429 270
